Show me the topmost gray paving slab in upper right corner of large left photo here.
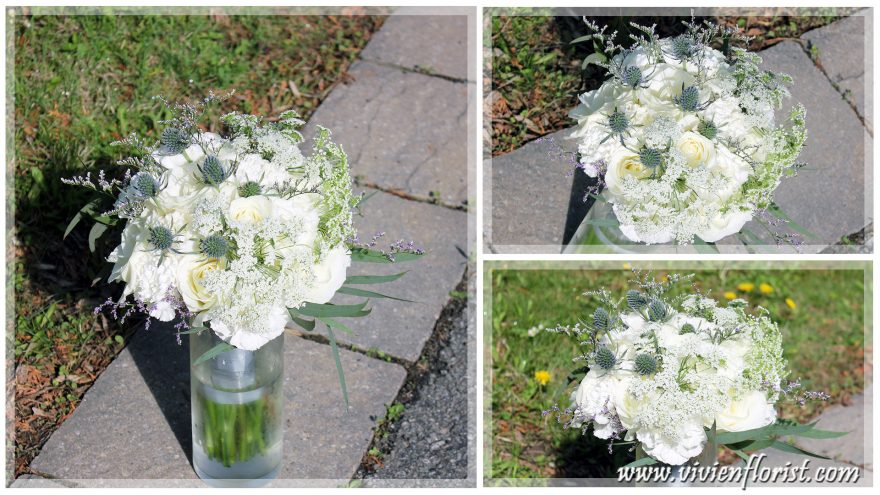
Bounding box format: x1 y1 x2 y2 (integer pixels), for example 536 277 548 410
360 9 474 81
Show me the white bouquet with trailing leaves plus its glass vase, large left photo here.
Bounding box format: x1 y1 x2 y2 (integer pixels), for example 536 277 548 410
66 94 423 479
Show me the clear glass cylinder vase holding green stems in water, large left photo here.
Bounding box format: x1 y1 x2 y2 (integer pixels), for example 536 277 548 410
190 330 284 487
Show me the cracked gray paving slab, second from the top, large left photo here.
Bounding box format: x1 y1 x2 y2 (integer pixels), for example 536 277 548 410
304 60 469 204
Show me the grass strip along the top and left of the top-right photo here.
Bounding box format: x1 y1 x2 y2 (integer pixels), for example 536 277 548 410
484 8 857 156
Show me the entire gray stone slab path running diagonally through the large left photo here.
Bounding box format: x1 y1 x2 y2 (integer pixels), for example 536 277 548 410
16 11 474 487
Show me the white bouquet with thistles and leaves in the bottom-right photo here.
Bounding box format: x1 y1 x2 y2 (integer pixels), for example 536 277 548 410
547 275 844 466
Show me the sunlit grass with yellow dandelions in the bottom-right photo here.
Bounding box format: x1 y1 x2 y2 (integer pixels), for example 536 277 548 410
486 269 871 478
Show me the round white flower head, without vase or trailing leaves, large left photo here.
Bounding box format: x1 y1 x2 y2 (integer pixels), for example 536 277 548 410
96 106 357 350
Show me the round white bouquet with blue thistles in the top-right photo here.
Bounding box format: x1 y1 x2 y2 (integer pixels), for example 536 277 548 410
571 19 806 244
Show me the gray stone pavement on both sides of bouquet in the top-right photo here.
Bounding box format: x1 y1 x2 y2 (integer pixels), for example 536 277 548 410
484 13 873 253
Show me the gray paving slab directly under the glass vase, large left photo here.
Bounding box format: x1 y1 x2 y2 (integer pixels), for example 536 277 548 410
31 327 406 486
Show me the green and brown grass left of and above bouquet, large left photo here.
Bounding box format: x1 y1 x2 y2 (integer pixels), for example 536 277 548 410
13 9 383 475
